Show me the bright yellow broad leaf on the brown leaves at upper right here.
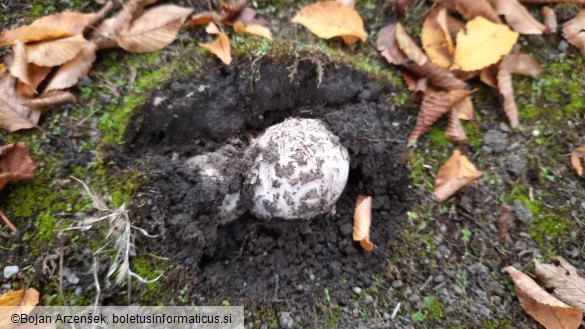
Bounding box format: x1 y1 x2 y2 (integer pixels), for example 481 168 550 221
451 16 518 71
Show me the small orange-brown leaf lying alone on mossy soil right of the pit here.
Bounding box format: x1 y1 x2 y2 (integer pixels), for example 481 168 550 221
435 150 481 202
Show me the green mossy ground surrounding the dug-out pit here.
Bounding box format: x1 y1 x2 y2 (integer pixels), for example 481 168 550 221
0 0 585 328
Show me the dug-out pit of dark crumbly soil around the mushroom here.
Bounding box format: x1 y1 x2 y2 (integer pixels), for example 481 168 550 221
126 60 411 305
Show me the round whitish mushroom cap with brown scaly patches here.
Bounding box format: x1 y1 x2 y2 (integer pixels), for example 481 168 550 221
248 118 349 219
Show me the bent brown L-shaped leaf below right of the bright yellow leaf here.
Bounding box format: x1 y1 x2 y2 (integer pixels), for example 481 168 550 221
498 54 543 128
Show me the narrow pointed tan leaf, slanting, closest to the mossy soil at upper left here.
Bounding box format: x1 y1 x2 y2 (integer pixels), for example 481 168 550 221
45 42 97 92
